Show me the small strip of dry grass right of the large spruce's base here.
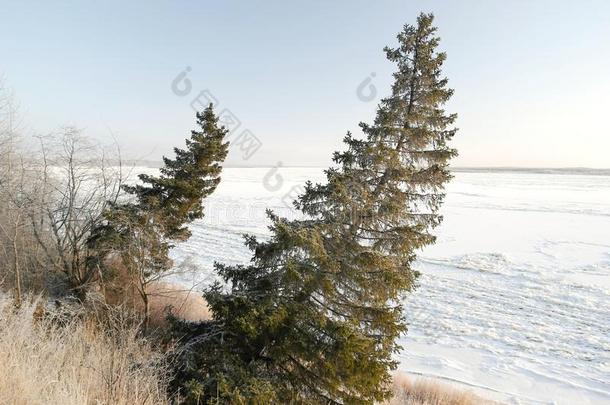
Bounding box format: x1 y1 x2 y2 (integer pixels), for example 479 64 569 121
385 375 493 405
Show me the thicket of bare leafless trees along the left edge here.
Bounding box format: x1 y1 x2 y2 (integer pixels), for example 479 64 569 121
0 77 123 301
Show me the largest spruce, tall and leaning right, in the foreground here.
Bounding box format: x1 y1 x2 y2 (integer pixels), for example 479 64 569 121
171 14 456 404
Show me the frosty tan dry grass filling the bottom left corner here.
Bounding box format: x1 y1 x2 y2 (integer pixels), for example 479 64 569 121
0 296 169 405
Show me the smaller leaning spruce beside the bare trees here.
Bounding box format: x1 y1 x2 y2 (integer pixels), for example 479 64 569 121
89 104 228 324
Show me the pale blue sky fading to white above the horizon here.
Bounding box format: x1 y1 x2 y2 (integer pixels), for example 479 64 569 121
0 0 610 167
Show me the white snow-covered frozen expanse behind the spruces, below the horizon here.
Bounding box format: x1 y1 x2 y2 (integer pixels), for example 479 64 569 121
159 168 610 405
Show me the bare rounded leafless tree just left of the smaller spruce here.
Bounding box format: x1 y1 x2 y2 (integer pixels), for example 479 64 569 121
30 128 123 295
